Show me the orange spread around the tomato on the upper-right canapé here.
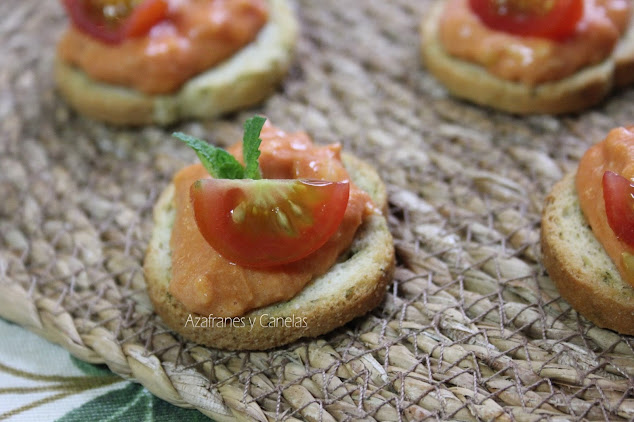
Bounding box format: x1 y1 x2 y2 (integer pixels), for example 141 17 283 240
439 0 630 86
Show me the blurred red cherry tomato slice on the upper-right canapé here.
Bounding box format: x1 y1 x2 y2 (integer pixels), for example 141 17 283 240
469 0 584 40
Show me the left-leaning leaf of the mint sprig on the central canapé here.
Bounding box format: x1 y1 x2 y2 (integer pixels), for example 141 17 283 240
172 132 243 179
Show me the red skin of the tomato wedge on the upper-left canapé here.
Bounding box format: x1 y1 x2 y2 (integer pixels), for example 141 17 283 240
62 0 168 44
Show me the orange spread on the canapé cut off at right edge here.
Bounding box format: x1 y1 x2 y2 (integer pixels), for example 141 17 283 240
575 126 634 286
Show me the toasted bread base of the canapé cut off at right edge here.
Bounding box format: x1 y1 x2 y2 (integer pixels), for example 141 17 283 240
541 173 634 335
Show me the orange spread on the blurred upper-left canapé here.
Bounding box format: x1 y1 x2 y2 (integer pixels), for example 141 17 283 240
58 0 268 94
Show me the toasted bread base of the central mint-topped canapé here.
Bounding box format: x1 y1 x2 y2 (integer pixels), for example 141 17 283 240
144 155 394 350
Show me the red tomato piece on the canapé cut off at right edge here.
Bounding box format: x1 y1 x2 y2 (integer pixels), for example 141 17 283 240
603 171 634 246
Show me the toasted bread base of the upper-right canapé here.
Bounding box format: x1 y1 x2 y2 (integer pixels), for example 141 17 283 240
421 0 634 114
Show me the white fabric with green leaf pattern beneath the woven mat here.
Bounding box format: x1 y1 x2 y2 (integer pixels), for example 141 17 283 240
0 319 208 422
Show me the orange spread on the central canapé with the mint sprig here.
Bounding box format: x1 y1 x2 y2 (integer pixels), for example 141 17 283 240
169 125 377 317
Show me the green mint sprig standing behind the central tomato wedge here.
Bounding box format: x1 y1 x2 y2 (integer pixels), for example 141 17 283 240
172 116 266 179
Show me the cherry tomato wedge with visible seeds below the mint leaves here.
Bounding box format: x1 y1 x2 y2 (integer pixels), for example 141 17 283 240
190 179 350 267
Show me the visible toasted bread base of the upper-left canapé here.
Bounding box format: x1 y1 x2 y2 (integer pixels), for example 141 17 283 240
54 0 297 125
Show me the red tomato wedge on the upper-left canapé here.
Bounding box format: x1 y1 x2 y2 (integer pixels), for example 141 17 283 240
62 0 168 44
